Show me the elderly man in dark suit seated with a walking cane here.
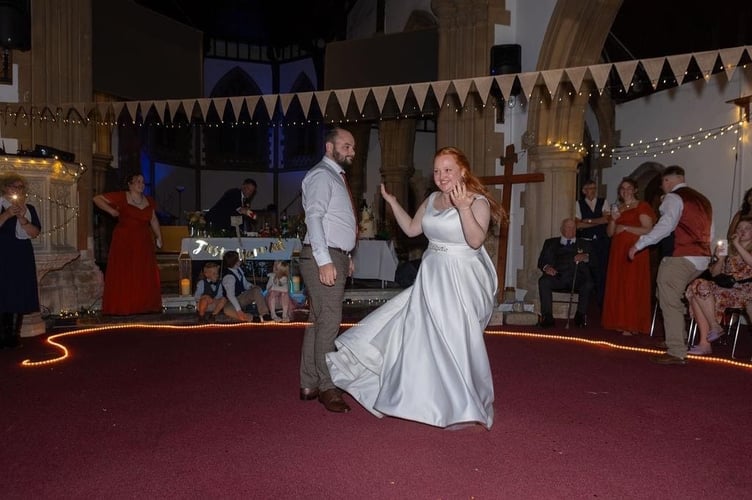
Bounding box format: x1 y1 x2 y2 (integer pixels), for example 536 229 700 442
538 219 593 327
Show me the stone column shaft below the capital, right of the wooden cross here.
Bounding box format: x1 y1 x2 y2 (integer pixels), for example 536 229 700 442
517 146 582 310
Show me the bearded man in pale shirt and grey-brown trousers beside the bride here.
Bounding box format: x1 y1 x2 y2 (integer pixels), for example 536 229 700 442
300 128 357 413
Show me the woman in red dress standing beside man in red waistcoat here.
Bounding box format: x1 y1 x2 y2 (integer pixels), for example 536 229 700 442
601 178 655 335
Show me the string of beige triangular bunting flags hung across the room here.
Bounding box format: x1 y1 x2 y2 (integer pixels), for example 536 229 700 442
0 46 752 122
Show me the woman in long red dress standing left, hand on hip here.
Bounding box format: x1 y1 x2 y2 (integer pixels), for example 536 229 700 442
94 174 162 315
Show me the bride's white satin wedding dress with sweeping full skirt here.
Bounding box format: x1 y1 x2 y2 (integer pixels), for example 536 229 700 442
327 193 497 429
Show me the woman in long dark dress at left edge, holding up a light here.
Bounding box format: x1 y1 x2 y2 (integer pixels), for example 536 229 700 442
0 173 41 349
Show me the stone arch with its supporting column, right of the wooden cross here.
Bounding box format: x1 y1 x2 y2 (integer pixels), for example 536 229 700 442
517 0 622 300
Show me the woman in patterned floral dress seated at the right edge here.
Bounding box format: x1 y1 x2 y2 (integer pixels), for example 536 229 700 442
686 217 752 355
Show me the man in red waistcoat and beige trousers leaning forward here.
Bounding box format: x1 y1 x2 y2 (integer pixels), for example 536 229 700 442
629 165 713 365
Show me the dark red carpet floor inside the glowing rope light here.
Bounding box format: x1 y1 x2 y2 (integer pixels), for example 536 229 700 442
0 327 752 499
